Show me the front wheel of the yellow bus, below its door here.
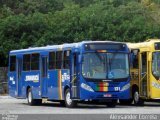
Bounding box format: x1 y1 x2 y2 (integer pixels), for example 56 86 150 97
133 90 144 105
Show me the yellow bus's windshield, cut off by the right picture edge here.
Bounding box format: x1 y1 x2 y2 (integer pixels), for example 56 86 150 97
152 52 160 79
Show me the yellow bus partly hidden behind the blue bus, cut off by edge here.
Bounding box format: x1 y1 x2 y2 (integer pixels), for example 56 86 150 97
128 39 160 105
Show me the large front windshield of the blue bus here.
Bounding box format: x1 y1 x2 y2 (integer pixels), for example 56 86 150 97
82 52 129 79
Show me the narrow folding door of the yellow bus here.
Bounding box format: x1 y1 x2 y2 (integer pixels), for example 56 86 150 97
139 52 148 97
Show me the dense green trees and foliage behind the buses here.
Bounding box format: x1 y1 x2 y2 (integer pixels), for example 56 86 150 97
0 0 160 66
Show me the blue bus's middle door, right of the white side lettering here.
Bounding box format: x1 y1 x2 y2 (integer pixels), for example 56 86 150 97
40 56 48 97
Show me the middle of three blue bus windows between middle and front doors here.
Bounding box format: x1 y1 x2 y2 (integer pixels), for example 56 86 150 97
56 51 62 69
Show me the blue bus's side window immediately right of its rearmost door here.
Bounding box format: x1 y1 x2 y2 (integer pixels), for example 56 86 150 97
23 54 31 71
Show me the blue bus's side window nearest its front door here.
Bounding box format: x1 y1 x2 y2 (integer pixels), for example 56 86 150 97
63 50 71 69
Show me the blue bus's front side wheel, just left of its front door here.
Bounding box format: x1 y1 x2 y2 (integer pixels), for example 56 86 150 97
65 89 77 108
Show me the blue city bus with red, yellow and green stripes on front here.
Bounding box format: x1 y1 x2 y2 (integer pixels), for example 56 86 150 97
8 41 130 107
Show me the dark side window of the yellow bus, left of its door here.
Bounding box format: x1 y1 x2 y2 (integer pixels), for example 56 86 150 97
131 49 139 69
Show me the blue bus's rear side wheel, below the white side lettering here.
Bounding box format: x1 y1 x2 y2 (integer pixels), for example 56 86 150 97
27 88 42 105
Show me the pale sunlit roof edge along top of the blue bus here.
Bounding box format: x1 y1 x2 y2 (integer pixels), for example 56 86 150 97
10 41 125 54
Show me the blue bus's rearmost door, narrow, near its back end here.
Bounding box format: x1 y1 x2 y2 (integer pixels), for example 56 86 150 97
16 57 22 98
